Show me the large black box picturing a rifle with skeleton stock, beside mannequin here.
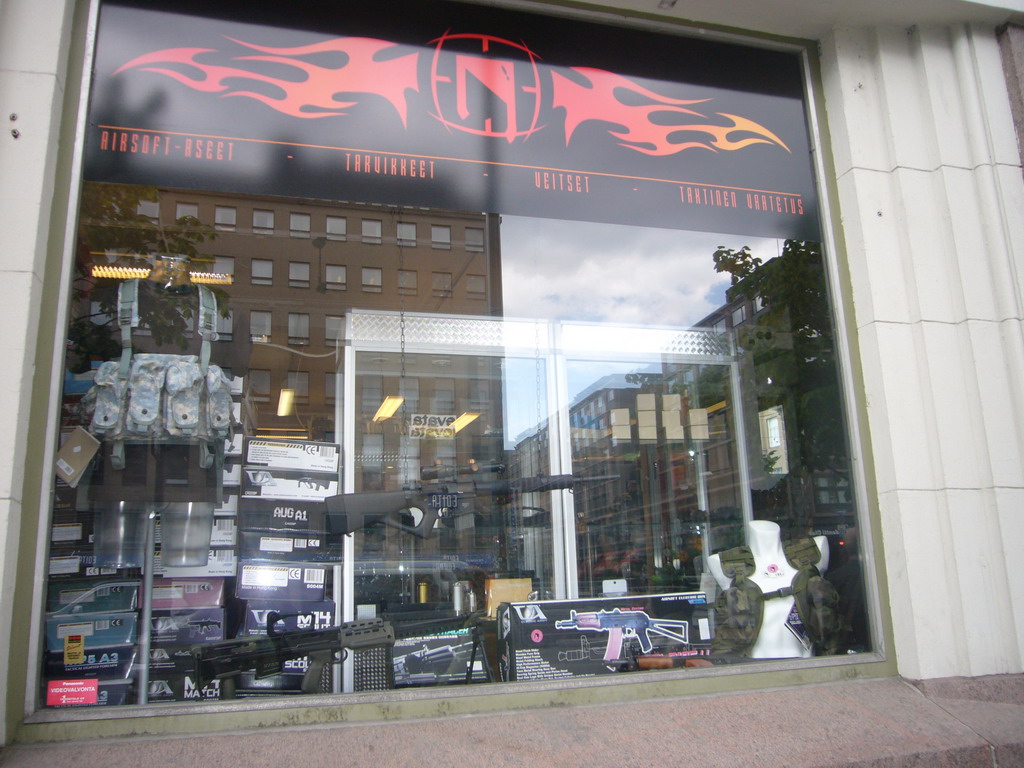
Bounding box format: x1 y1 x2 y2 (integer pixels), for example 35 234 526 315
498 592 711 681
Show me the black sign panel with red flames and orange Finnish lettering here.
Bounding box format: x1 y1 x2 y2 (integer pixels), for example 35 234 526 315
86 0 818 239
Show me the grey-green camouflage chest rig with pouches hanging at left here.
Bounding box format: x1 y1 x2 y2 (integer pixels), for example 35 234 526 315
82 280 233 469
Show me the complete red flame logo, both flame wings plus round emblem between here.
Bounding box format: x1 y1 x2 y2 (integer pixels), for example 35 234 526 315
115 35 790 156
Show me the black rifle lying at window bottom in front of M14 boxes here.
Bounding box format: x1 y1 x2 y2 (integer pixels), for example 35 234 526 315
191 611 394 698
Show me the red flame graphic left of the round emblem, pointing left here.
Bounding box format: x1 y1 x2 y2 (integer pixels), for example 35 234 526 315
115 37 417 125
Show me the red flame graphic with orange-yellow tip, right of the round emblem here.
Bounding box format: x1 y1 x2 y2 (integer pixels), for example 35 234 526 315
552 67 790 155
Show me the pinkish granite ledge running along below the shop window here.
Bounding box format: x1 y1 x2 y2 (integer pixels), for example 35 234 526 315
0 675 1024 768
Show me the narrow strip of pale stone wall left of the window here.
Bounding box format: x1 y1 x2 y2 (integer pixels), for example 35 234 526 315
0 0 77 742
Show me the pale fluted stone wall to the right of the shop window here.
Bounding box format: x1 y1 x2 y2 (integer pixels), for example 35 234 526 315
822 26 1024 678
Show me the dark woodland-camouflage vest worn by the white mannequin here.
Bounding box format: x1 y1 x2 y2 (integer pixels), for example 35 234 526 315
712 539 844 656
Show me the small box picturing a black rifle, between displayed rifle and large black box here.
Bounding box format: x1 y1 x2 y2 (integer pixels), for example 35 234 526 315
392 628 487 687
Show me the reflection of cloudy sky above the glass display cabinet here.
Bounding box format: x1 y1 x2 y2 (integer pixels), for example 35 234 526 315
501 215 776 328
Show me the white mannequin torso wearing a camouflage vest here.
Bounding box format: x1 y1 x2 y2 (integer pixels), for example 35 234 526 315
708 520 828 658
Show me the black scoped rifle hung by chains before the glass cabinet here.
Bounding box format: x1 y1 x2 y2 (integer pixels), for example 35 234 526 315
324 464 617 539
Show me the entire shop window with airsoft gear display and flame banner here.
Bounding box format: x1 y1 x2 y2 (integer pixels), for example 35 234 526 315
39 3 870 707
